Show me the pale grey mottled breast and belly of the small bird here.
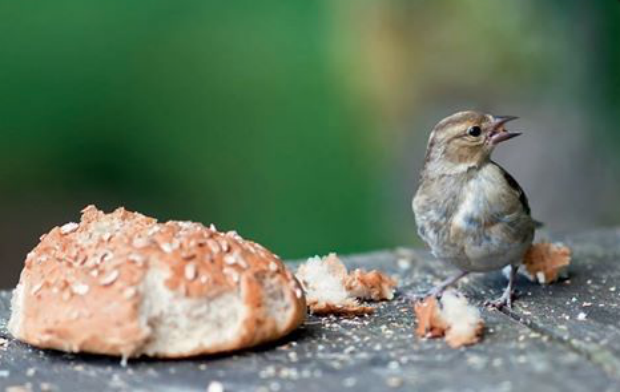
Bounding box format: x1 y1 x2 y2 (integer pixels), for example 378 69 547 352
413 164 534 272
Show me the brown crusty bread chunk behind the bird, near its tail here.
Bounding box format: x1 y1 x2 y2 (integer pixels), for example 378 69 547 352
520 242 571 284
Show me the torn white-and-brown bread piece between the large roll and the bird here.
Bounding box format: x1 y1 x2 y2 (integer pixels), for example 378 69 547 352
296 253 396 316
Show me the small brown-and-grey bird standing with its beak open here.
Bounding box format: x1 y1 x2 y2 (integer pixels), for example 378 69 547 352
412 110 537 309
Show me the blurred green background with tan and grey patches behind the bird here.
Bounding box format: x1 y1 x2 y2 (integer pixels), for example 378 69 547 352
0 0 620 287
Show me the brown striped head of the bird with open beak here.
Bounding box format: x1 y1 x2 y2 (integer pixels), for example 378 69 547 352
425 111 520 173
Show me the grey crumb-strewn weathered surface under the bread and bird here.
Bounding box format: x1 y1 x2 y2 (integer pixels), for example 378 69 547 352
0 230 620 392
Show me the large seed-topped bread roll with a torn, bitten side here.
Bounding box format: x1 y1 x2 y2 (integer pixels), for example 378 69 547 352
8 206 306 358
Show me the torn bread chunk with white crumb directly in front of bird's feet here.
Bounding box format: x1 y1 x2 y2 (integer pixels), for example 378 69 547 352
414 290 484 348
